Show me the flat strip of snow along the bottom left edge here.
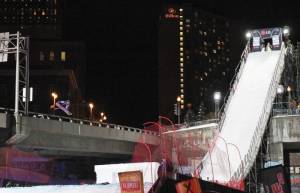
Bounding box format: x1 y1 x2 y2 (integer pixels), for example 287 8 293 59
0 183 151 193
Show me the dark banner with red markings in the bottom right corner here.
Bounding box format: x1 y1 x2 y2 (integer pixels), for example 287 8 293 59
262 165 291 193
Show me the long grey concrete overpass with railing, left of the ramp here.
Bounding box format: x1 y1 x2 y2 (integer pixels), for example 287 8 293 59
0 108 159 158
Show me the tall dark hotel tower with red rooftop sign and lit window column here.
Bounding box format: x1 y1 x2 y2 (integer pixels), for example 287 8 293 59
158 4 237 120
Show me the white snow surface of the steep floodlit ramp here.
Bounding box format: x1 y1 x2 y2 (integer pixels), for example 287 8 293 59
201 51 280 182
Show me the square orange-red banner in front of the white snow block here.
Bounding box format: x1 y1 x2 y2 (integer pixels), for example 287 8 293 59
118 171 144 193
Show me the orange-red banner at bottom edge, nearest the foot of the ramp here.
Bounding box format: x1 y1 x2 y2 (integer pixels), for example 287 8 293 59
176 178 202 193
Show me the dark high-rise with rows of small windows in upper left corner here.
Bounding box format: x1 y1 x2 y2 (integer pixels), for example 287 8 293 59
0 0 61 39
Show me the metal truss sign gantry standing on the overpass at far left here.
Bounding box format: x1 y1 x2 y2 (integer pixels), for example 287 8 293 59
0 32 30 115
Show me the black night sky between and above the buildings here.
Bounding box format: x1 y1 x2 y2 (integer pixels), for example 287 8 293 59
62 0 300 127
